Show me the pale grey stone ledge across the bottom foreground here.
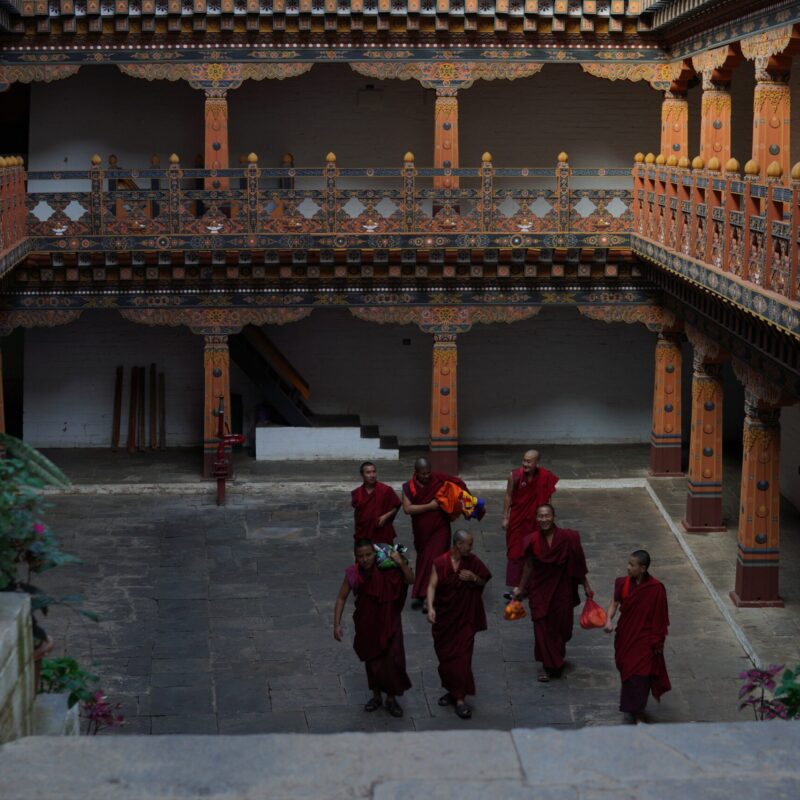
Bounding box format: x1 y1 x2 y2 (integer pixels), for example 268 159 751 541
0 722 800 800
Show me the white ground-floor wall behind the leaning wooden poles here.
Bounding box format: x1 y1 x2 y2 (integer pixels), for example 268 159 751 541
24 311 203 447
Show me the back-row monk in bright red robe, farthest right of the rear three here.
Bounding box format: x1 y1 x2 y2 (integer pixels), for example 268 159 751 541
503 450 558 586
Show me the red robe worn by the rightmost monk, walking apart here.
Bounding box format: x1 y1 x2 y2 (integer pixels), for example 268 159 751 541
614 575 672 700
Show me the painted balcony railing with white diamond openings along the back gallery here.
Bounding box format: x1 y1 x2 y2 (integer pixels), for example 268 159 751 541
20 153 633 252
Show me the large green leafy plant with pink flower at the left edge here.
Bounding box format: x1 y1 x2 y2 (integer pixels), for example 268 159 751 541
0 434 98 646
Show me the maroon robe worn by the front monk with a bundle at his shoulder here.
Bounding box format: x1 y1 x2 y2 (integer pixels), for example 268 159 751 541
348 566 411 695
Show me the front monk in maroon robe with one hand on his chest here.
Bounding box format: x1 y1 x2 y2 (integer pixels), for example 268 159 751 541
428 530 492 719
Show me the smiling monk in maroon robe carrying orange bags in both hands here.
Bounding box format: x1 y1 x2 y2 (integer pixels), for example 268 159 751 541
514 503 592 683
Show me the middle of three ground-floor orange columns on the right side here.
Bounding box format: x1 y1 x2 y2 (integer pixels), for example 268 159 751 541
683 348 726 533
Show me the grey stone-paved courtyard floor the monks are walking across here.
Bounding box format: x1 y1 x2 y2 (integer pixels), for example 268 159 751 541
36 489 749 734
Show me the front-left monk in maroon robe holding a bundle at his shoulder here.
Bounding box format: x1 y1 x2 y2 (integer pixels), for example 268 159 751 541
333 539 414 717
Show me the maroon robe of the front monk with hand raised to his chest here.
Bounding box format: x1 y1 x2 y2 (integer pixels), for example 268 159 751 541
433 551 492 700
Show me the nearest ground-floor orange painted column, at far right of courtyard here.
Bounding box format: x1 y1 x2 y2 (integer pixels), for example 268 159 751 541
731 404 783 607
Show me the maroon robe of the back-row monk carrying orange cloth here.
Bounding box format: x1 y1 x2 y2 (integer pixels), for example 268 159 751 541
403 472 467 599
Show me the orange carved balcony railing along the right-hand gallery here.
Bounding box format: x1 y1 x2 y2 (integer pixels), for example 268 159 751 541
633 155 800 306
